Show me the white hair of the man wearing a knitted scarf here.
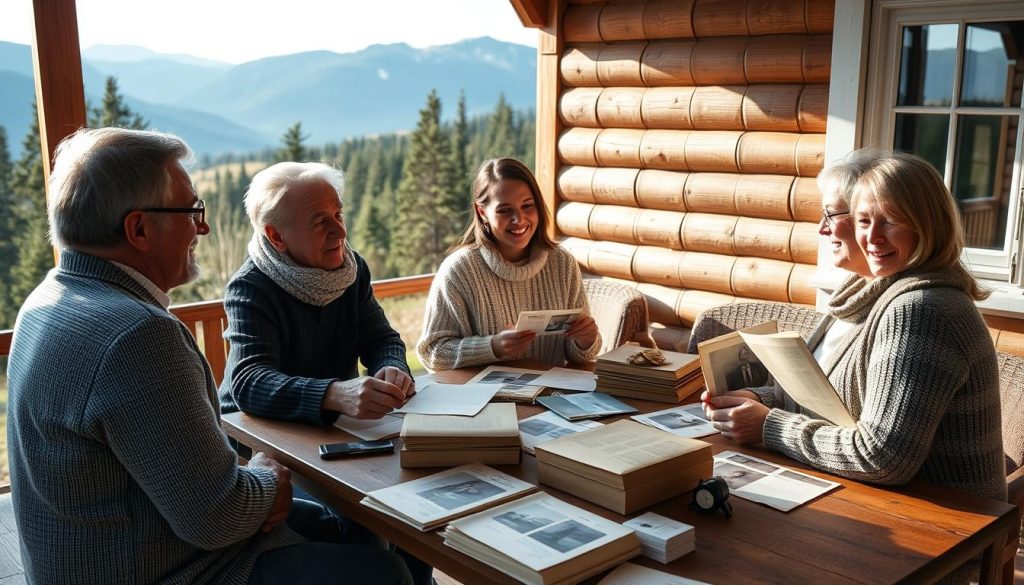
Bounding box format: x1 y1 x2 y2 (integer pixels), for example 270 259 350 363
245 162 345 234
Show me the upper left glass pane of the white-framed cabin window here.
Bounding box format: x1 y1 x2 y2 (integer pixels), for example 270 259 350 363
896 25 959 106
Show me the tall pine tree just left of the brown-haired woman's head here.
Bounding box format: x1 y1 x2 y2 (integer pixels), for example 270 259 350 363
390 90 462 275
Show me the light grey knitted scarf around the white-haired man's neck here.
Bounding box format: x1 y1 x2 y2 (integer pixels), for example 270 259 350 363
249 233 355 306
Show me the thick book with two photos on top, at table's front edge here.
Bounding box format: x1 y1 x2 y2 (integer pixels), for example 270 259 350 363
443 493 640 585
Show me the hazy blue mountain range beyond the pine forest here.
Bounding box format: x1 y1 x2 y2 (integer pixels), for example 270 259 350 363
0 37 537 158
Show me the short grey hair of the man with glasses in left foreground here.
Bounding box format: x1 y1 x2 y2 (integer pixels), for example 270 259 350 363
47 128 193 248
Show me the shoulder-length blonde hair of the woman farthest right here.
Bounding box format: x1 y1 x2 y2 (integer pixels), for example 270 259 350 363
851 153 991 300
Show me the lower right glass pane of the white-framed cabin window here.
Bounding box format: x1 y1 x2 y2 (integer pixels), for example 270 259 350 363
952 116 1020 249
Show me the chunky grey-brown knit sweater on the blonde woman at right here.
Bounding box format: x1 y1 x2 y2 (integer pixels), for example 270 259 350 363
759 270 1007 500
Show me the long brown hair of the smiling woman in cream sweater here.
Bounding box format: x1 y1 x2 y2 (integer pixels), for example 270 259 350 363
449 159 555 253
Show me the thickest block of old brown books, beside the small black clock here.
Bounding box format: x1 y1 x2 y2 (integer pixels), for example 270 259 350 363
534 420 714 514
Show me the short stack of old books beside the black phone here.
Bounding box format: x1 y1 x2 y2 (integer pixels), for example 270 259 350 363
399 403 522 467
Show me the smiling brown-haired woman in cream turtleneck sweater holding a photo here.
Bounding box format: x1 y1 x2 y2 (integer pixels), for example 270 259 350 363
417 159 601 370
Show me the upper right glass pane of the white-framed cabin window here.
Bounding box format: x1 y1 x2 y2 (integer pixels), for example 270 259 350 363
961 20 1024 107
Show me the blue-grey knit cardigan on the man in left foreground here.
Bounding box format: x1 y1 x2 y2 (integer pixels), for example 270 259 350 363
7 250 301 584
